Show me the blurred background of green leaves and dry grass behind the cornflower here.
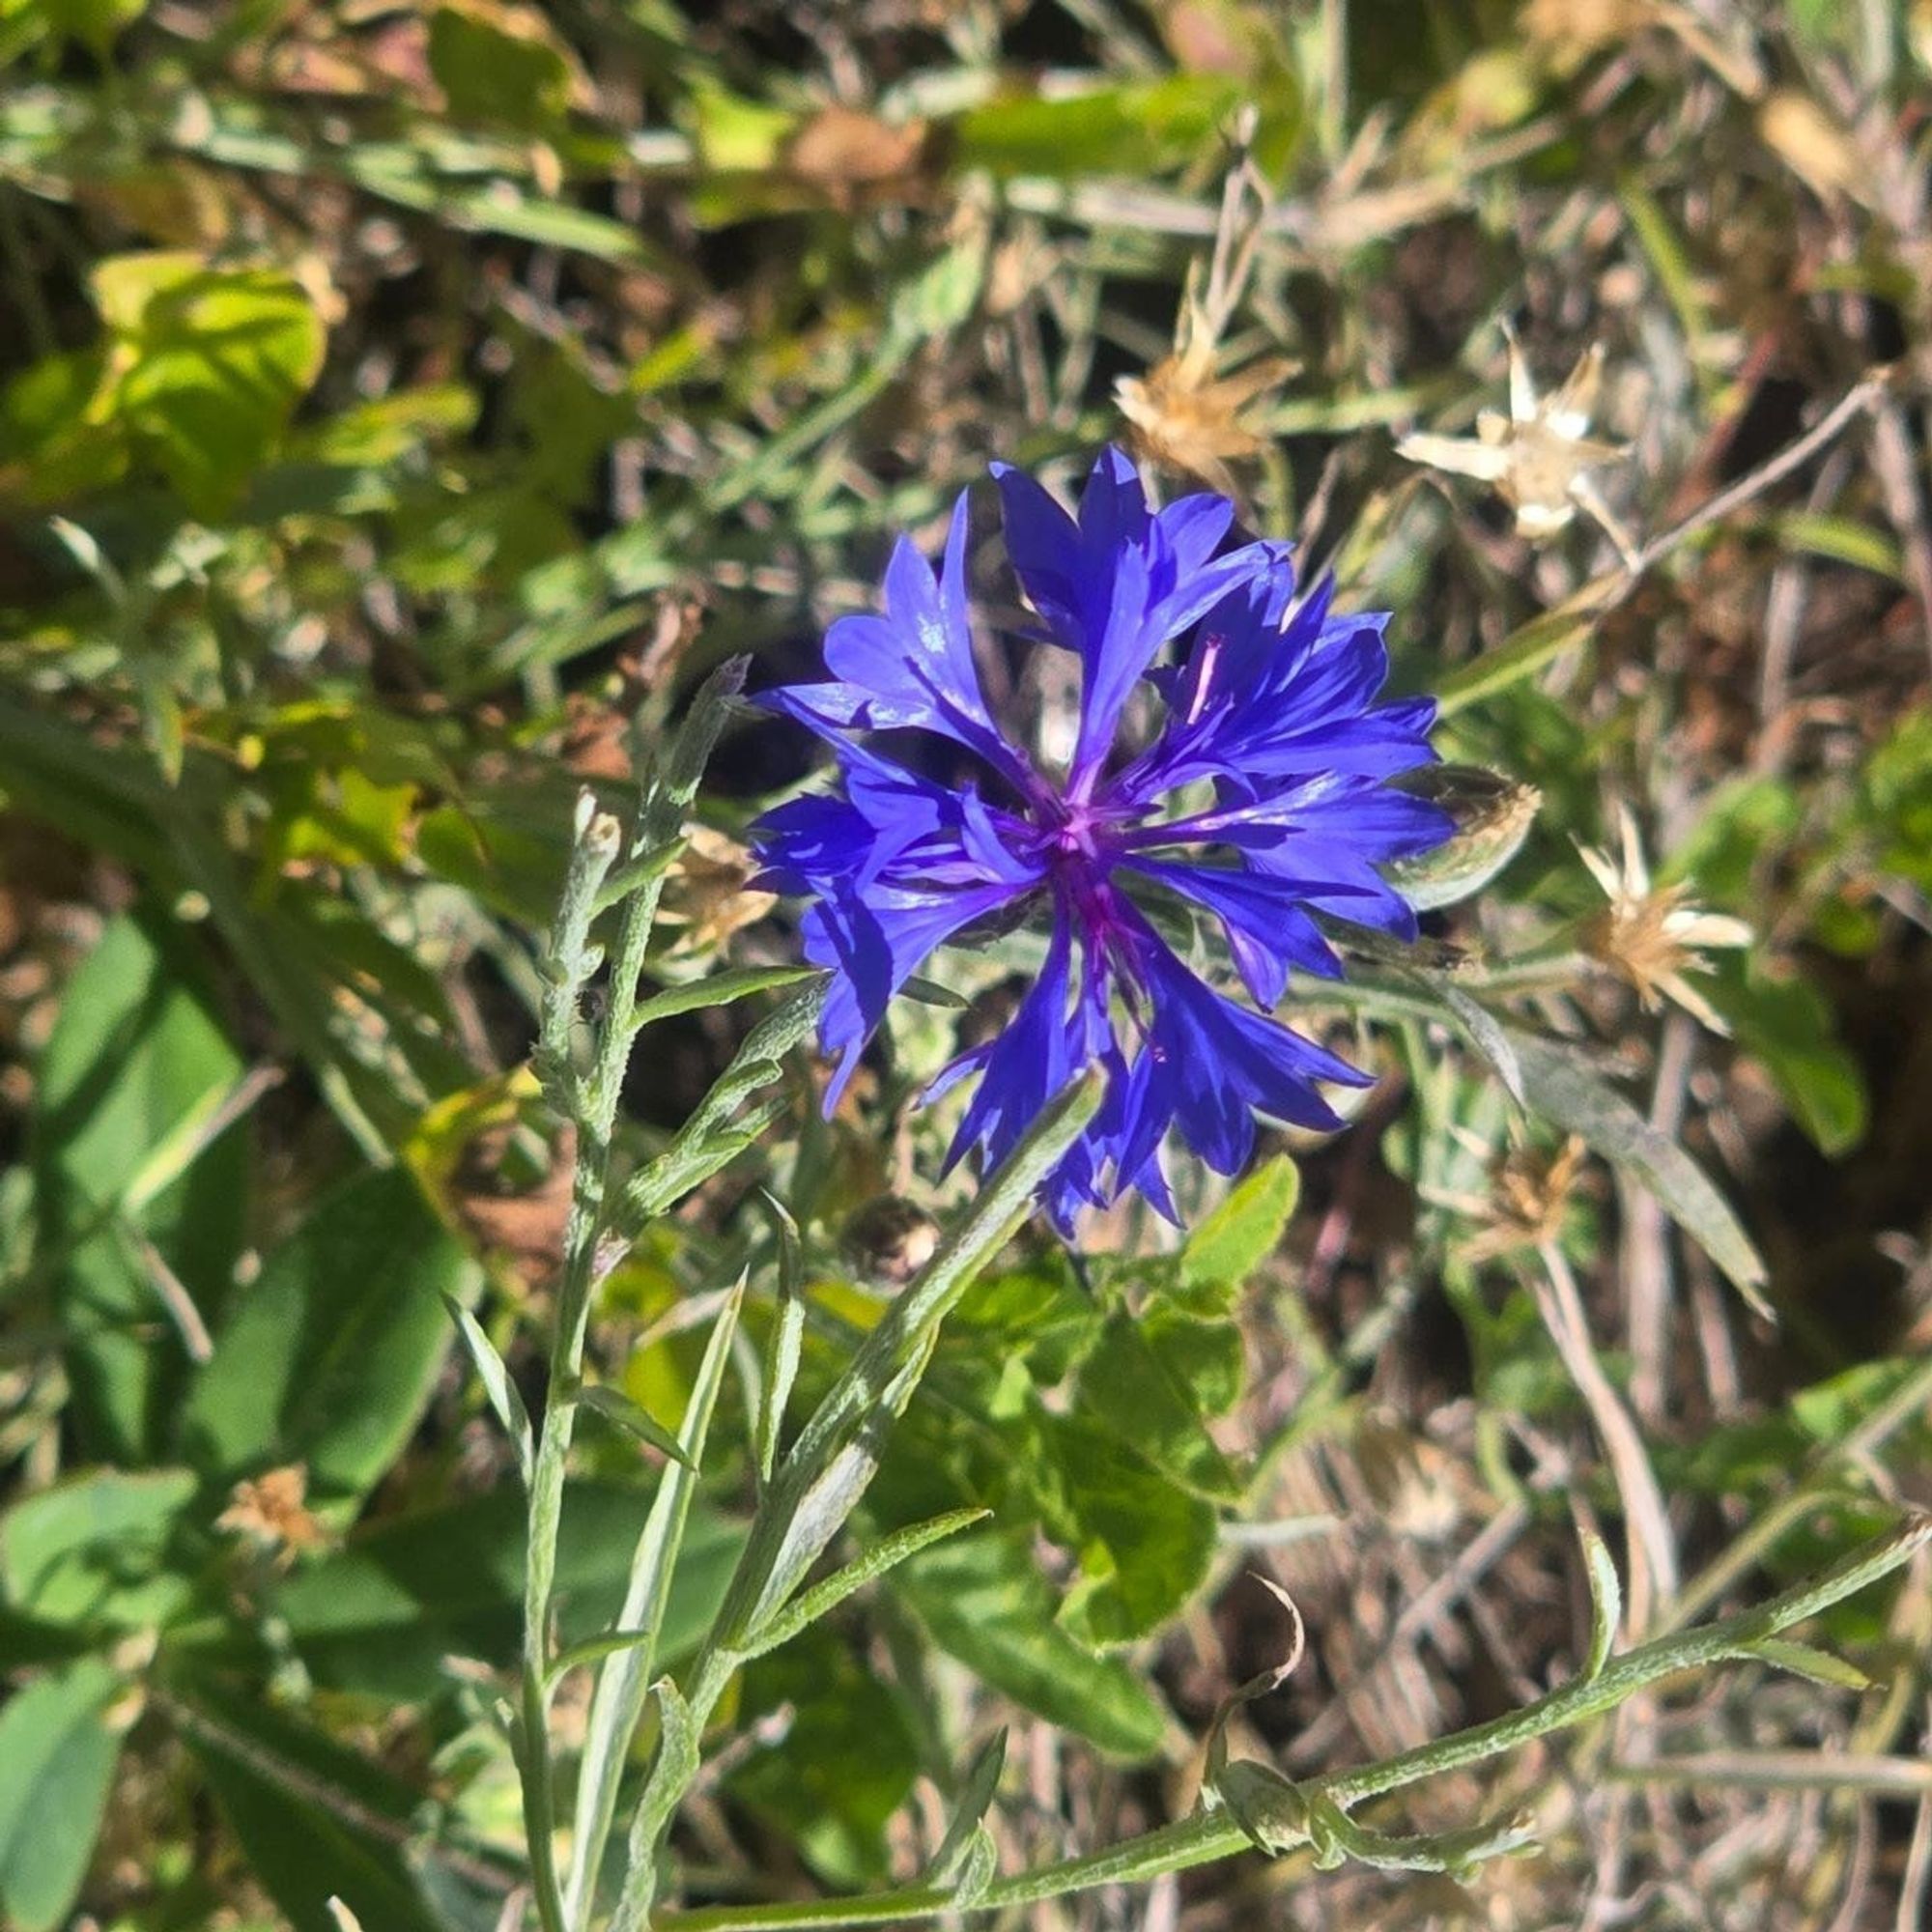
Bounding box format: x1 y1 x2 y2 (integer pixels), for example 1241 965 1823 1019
0 0 1932 1932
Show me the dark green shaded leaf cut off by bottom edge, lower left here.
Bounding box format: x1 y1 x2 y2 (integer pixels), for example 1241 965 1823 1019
168 1681 450 1932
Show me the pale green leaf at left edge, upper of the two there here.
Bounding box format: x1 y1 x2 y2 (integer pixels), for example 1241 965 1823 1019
0 1468 199 1631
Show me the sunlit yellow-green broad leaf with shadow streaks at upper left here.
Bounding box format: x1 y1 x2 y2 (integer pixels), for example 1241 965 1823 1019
93 253 325 518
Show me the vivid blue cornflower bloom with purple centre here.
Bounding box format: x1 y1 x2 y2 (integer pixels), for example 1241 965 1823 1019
755 448 1451 1227
